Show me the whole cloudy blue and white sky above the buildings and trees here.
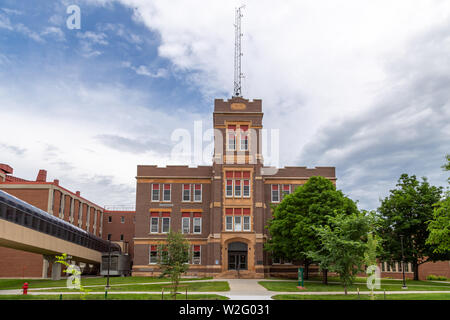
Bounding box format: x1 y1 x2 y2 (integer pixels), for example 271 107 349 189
0 0 450 210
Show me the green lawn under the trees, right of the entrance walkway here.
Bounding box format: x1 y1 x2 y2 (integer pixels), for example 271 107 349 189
258 279 450 292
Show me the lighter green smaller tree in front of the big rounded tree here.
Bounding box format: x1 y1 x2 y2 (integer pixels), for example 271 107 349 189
307 212 370 294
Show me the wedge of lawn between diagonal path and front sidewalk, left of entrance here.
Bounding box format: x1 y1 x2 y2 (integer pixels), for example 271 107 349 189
31 281 230 292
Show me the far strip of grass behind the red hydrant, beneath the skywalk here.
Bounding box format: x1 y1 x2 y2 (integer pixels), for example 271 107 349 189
0 277 212 290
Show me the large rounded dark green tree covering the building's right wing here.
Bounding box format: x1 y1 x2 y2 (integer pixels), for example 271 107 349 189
265 177 358 283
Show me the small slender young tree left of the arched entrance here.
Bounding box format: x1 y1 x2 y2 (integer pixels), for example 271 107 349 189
158 230 190 299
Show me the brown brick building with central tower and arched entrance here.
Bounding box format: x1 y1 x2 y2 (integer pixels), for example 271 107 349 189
133 97 336 277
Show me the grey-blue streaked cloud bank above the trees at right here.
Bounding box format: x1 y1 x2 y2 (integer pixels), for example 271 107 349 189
299 23 450 209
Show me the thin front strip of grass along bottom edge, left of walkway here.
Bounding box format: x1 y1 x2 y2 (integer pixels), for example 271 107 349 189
0 294 228 300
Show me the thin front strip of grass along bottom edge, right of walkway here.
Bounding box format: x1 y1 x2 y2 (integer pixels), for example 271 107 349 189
272 292 450 300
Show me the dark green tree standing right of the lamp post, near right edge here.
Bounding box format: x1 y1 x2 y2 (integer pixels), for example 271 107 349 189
378 174 448 280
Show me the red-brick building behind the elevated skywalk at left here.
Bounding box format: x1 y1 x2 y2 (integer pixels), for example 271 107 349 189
0 164 103 277
